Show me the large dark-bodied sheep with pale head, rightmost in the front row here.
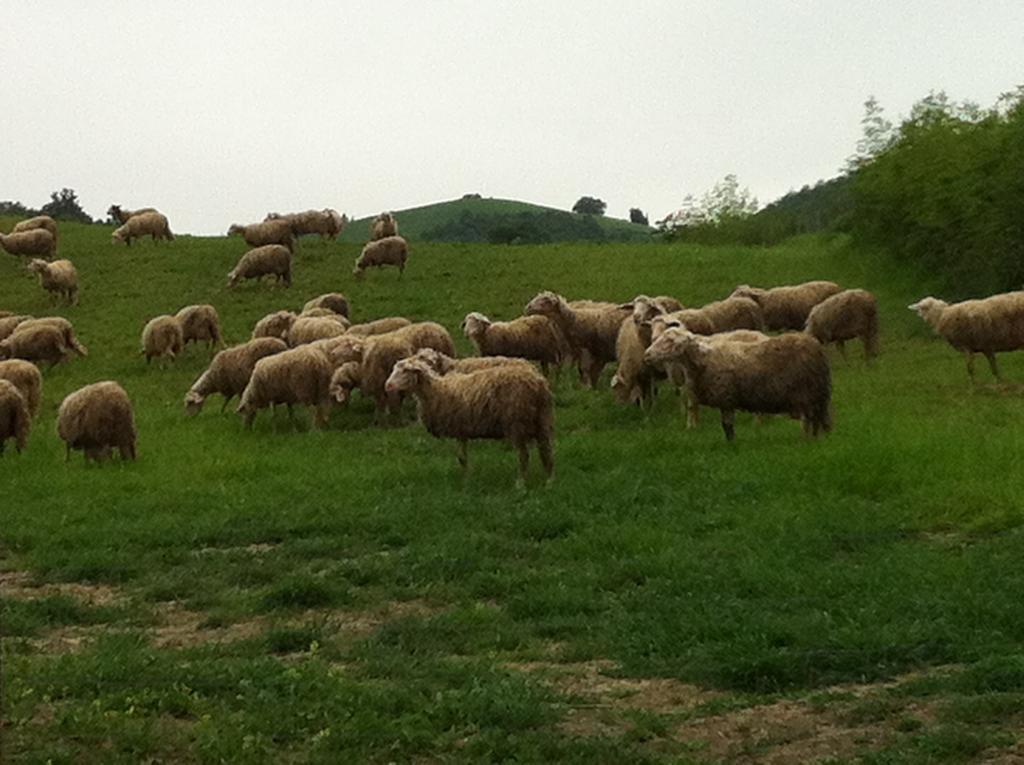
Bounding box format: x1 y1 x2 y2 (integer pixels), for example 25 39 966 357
644 327 831 441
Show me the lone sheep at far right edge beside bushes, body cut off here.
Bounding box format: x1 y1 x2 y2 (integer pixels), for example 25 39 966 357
907 292 1024 382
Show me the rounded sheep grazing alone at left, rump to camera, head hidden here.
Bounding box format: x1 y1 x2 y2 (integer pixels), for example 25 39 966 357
57 380 138 462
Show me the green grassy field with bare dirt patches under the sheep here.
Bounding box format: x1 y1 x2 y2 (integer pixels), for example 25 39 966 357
0 221 1024 763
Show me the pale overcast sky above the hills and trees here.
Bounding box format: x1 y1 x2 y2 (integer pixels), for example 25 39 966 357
6 0 1024 233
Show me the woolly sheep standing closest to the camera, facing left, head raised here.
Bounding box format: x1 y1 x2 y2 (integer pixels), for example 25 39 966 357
385 358 554 486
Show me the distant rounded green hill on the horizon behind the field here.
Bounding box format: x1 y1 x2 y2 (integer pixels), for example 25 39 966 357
340 197 654 244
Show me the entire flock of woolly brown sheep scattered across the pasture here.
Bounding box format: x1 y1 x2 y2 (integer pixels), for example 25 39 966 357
0 206 1024 481
